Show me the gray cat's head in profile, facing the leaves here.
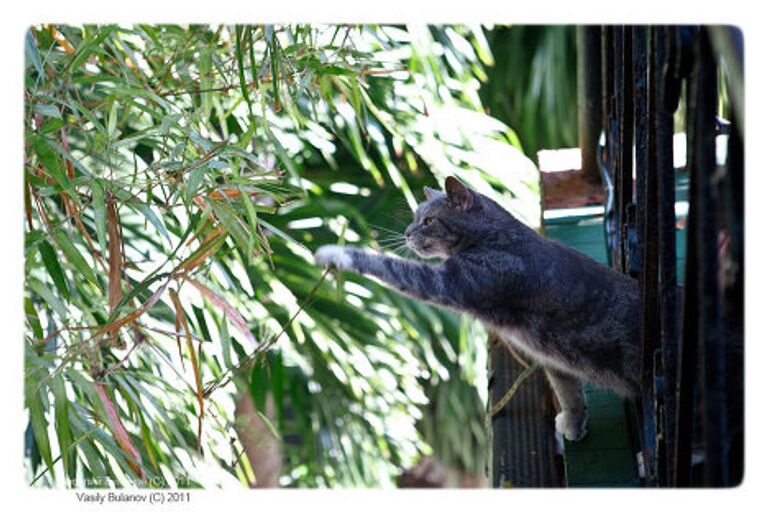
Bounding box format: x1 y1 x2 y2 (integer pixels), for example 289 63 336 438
405 177 487 259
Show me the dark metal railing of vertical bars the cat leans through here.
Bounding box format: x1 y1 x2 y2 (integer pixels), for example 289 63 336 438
579 26 744 487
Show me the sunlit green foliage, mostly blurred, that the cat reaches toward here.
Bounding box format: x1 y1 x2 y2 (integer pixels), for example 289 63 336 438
24 25 577 488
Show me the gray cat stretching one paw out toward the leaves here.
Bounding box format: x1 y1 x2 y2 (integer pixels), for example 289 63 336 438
315 177 640 441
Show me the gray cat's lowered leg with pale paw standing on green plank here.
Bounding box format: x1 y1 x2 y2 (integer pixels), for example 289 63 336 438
545 368 587 441
